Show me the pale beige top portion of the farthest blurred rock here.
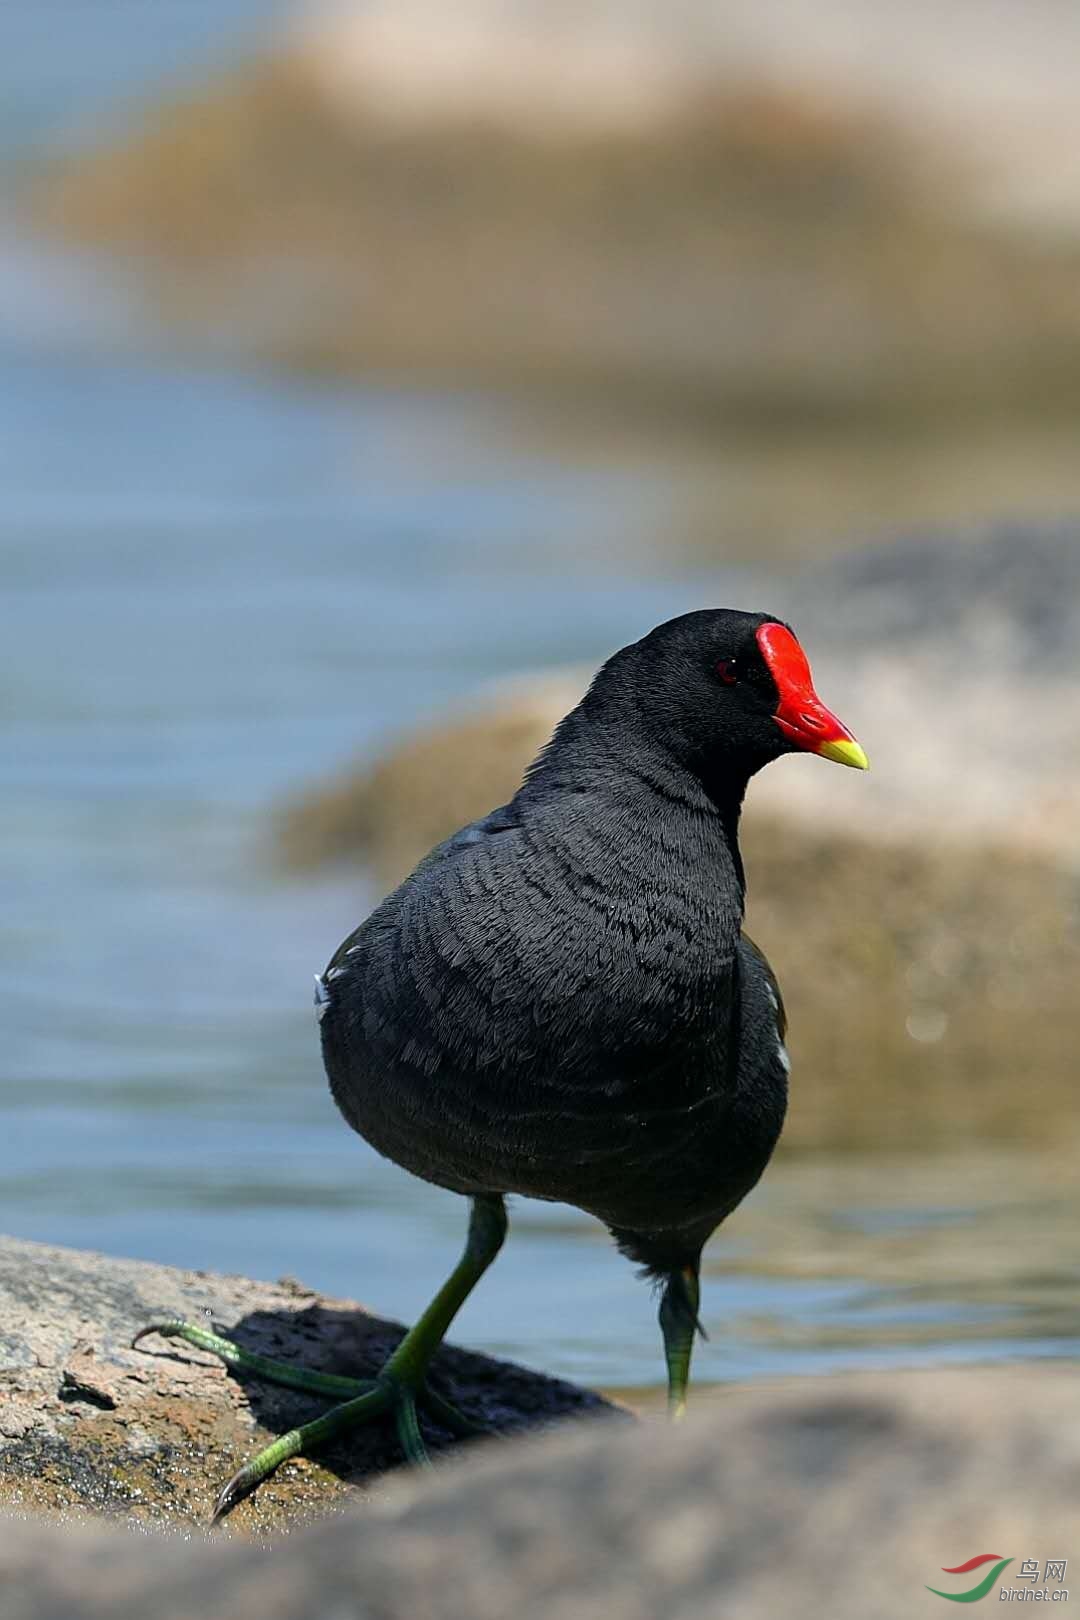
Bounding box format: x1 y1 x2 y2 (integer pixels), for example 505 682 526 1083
300 0 1080 222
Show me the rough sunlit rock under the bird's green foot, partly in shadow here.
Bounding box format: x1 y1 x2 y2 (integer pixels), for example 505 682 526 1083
0 1238 615 1535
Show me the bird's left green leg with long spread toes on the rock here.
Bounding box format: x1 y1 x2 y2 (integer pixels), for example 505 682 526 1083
134 1196 507 1520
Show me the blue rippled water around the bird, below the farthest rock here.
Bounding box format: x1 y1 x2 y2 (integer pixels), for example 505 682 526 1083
0 332 1080 1387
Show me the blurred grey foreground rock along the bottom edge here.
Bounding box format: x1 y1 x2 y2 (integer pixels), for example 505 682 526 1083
0 1367 1080 1620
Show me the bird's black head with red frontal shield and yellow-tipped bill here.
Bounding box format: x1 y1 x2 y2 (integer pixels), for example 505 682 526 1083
591 608 866 784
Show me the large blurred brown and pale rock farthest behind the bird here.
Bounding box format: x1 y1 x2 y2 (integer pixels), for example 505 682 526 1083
33 0 1080 431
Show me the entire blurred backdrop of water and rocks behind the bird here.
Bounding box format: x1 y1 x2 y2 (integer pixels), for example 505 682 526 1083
0 0 1080 1390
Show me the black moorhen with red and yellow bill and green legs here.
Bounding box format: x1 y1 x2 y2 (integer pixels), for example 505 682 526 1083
136 608 868 1518
